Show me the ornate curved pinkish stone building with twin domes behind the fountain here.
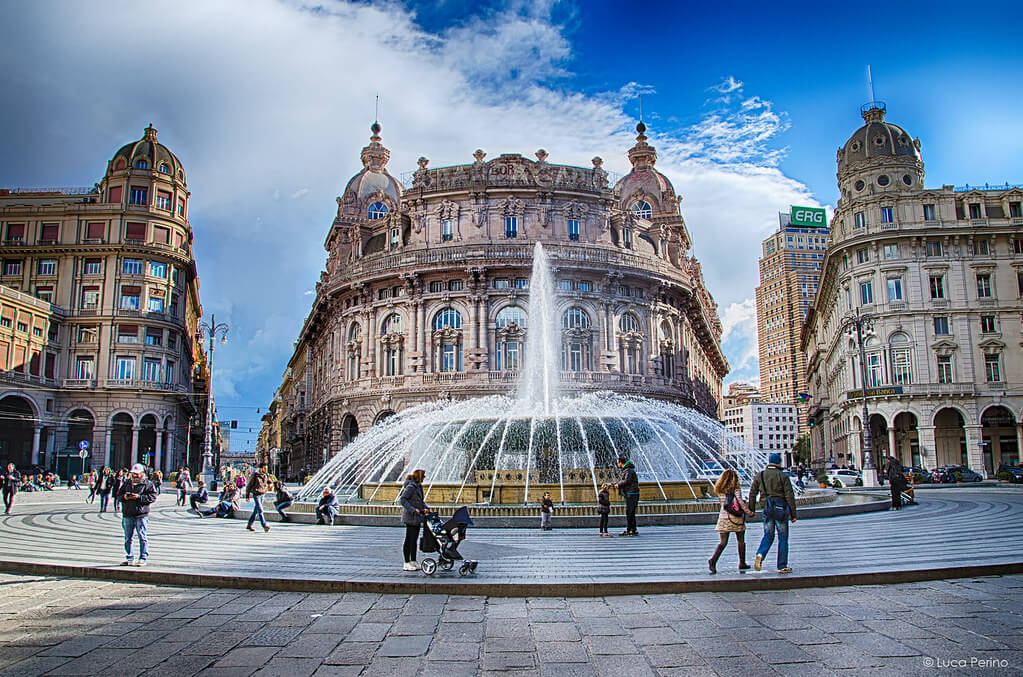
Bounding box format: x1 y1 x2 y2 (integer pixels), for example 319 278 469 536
261 123 728 482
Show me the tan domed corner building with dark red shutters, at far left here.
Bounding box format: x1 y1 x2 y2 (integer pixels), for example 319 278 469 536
0 126 209 476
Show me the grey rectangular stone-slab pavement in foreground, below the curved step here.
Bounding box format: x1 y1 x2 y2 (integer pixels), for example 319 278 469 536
0 574 1023 677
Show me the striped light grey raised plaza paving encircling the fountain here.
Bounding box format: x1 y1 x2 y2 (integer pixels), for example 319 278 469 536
0 488 1023 592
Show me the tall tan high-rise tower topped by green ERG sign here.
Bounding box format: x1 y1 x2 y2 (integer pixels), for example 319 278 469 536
756 210 829 430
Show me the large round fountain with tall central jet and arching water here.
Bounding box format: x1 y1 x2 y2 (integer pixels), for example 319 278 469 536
300 242 766 505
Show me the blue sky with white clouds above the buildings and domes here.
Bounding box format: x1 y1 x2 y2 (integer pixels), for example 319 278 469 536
0 0 1023 450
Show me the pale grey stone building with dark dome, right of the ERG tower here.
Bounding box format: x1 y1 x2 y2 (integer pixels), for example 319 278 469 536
802 103 1023 476
